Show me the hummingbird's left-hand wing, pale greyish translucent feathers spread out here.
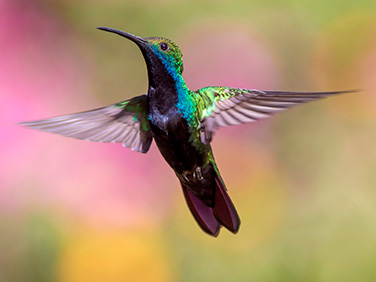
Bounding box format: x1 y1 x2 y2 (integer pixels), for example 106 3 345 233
21 95 153 153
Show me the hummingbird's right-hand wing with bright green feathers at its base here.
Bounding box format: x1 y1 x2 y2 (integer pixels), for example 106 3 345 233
194 87 355 143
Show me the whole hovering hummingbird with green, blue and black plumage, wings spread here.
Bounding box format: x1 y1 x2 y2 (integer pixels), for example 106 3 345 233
22 27 353 237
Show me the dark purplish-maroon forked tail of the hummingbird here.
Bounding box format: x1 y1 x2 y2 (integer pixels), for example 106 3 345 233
181 168 240 237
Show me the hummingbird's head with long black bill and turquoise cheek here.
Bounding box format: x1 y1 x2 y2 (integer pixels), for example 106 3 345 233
98 27 183 82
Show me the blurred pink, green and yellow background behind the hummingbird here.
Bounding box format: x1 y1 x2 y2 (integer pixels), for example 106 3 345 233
0 0 376 282
